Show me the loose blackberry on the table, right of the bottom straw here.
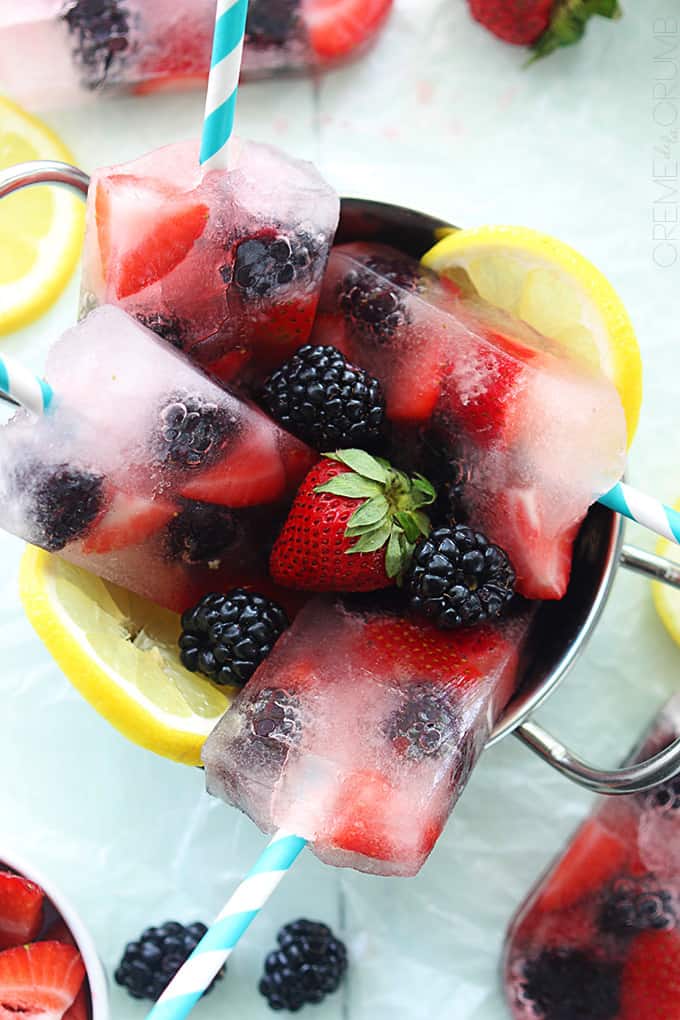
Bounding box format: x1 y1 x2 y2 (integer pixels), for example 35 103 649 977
259 918 347 1013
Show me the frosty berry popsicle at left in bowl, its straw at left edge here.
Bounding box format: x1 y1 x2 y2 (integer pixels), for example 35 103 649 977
0 307 315 610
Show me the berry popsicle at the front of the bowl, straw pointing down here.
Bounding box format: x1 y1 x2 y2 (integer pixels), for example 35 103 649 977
203 599 527 875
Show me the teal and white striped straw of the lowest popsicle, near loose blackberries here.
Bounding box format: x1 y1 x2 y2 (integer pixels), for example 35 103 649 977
147 831 307 1020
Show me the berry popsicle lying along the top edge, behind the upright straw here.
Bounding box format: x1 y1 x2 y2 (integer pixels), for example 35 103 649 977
0 0 393 106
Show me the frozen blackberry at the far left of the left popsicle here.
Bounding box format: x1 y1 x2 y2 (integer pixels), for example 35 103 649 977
14 461 104 553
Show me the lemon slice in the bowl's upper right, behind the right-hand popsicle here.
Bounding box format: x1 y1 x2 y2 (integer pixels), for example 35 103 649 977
422 226 642 446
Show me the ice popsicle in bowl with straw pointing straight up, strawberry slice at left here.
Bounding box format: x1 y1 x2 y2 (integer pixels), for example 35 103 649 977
82 141 339 384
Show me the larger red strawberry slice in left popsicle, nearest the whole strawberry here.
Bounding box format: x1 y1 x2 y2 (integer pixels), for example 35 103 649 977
181 421 286 508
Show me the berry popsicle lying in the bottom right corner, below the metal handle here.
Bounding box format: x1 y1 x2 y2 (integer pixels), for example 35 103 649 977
505 696 680 1020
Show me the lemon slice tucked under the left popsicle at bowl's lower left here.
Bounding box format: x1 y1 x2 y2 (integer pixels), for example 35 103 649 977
19 546 236 765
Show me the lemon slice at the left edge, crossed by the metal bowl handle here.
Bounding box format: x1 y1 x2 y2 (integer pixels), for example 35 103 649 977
0 97 85 334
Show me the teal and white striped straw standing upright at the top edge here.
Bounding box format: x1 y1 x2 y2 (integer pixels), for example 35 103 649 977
199 0 248 170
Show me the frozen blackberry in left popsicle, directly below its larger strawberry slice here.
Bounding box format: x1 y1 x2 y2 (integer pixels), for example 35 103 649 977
165 501 240 564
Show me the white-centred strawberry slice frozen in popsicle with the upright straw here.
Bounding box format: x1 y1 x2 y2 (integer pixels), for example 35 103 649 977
95 173 209 299
